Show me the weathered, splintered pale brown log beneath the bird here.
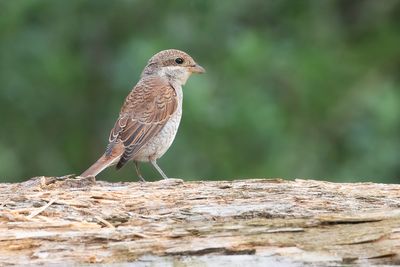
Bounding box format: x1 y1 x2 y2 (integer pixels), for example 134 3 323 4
0 177 400 266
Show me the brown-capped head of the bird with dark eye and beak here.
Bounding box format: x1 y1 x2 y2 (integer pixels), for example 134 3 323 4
142 49 205 85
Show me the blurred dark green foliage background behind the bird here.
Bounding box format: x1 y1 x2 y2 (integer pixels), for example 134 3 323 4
0 0 400 182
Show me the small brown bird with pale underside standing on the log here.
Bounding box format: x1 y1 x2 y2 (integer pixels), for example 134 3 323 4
80 49 205 182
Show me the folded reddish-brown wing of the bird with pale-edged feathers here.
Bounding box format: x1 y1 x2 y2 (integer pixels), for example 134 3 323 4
106 76 178 168
